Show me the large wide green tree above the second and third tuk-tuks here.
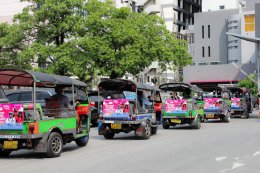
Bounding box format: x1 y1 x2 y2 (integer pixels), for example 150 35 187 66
80 0 191 78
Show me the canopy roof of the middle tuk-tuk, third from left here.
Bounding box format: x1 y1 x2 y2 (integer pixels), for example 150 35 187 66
159 83 203 92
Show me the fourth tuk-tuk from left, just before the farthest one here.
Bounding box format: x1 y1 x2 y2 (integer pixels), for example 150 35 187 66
202 86 230 122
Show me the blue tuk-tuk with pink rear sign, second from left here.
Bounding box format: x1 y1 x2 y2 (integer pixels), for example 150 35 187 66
98 79 161 139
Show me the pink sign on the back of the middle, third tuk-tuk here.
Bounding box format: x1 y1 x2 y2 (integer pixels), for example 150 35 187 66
165 99 187 114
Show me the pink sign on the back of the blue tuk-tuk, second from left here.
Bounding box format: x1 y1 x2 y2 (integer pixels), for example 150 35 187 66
102 99 129 117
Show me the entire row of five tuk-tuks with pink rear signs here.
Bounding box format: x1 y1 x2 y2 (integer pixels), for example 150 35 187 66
0 69 252 157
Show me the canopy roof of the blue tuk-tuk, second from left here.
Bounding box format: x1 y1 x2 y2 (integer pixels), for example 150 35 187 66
98 79 160 91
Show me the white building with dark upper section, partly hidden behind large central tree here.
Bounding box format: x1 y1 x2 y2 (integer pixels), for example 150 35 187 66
137 0 202 84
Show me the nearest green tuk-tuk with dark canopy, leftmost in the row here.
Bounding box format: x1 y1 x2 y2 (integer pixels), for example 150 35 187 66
0 69 90 157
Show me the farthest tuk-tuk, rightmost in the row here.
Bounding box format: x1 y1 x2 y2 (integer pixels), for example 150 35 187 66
227 86 253 118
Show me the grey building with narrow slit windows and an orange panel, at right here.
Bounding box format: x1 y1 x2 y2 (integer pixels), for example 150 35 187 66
184 0 260 84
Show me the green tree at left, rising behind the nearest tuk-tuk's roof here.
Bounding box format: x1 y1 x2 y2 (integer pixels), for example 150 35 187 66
15 0 87 79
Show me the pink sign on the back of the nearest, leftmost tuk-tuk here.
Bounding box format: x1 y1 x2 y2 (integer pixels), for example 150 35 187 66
0 104 24 130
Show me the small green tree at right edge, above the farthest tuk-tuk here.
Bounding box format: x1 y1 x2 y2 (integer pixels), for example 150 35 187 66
238 74 257 95
